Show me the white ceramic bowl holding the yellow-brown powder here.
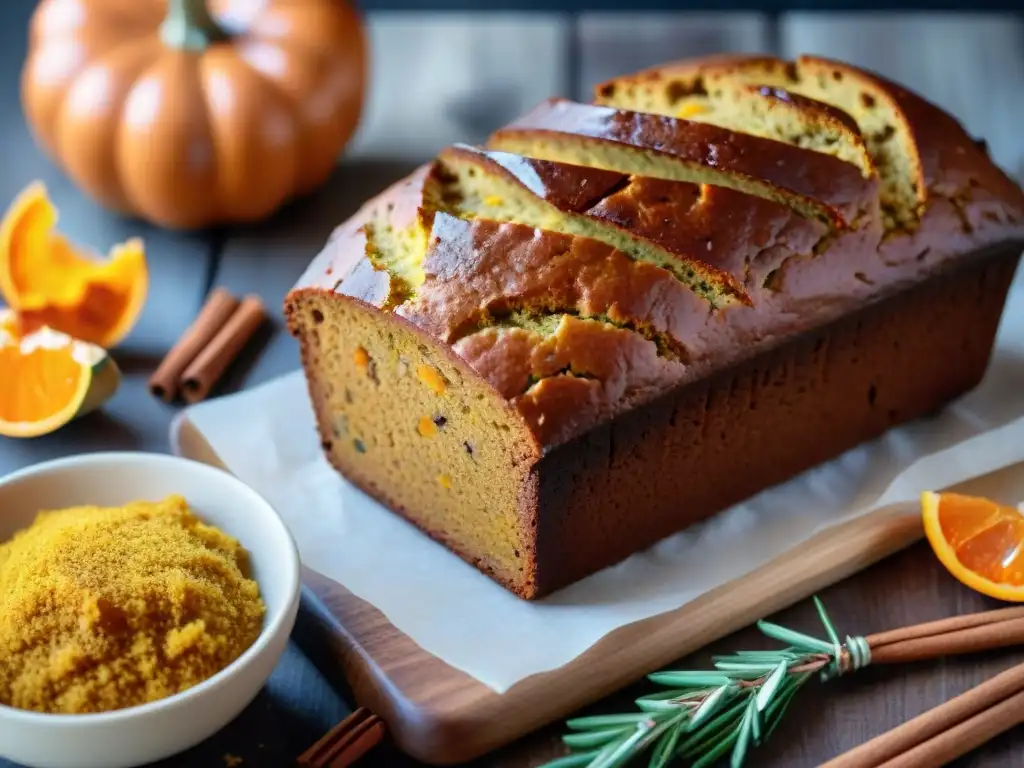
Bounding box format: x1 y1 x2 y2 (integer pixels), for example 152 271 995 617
0 453 299 768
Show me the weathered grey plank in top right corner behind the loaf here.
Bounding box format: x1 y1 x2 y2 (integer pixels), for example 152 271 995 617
780 13 1024 175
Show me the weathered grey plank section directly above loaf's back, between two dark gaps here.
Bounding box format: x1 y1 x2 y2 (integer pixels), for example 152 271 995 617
575 12 771 99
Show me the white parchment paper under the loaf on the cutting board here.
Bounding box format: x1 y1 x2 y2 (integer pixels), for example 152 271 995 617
171 275 1024 692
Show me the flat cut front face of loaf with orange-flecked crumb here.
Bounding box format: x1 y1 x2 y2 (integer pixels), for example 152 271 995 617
291 294 534 593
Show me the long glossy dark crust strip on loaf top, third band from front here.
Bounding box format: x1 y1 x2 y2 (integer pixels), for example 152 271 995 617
487 98 878 228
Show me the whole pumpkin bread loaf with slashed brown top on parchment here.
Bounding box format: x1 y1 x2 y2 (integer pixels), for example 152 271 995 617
286 56 1024 599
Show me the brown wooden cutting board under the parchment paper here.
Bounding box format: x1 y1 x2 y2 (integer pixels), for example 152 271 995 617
179 420 1021 765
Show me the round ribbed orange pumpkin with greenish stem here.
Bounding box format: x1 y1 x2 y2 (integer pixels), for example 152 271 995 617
22 0 366 229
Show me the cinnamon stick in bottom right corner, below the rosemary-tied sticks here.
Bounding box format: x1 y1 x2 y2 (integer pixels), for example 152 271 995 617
819 664 1024 768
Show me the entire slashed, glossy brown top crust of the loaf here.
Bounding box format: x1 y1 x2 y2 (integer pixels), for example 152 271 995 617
293 56 1024 447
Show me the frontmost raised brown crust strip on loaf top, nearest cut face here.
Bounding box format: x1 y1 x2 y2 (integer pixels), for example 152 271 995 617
397 213 709 360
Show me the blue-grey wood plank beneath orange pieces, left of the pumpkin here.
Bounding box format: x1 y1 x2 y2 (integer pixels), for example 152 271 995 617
0 2 211 474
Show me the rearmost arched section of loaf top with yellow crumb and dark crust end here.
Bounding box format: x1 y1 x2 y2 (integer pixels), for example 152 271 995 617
595 55 1020 230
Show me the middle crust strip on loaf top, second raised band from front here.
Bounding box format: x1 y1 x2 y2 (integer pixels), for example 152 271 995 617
439 145 828 306
